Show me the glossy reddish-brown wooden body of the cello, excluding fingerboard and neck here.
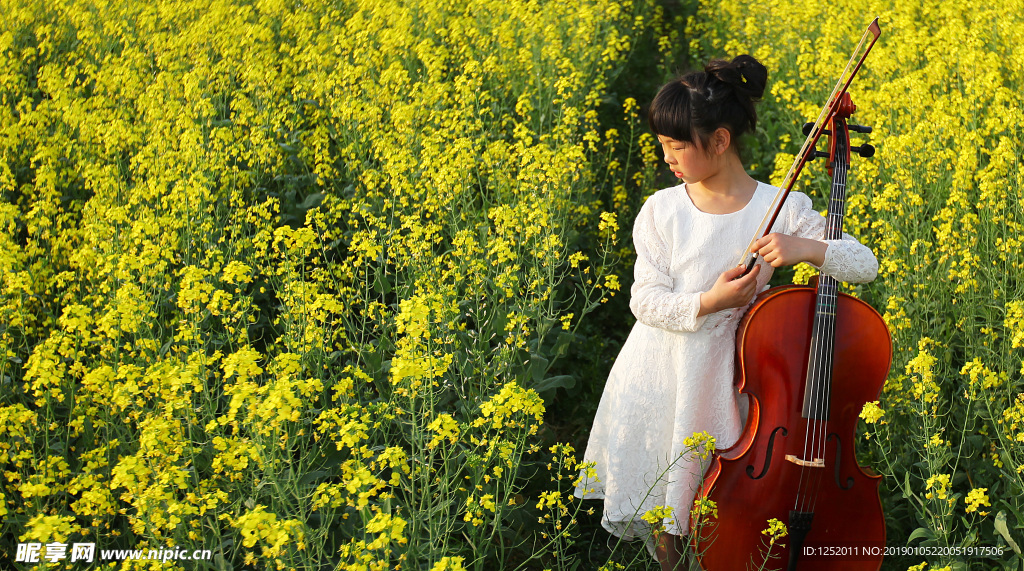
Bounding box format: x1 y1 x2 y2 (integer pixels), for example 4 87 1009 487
691 286 892 571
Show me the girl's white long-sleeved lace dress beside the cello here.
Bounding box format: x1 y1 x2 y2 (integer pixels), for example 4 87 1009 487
575 183 878 539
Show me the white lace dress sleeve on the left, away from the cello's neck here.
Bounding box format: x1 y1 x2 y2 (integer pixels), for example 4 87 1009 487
630 199 707 332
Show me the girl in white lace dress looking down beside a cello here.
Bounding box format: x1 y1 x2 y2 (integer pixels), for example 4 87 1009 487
575 55 878 569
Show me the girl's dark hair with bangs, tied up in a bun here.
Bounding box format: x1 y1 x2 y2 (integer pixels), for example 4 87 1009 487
647 55 768 149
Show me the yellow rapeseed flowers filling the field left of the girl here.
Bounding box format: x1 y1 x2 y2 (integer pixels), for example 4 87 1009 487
0 0 678 570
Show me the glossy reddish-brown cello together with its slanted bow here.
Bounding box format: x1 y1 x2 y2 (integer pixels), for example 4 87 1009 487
690 18 892 571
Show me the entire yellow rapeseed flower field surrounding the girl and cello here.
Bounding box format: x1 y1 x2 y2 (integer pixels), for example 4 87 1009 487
6 0 1024 571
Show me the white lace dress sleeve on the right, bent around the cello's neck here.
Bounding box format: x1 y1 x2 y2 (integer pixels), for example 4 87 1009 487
788 192 879 283
